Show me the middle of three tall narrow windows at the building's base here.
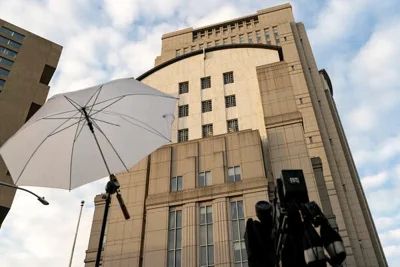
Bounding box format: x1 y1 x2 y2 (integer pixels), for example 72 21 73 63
200 206 214 267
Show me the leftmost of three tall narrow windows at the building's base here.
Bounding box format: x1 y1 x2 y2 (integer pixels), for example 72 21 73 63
167 208 182 267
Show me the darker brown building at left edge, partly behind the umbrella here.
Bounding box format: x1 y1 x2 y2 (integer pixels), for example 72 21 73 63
0 20 62 226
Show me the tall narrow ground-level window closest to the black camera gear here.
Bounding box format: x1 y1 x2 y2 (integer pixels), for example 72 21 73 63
231 200 248 267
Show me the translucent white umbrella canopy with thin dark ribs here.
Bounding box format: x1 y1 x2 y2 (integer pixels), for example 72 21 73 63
0 78 176 190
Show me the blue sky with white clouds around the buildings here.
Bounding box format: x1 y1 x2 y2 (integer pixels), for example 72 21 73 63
0 0 400 267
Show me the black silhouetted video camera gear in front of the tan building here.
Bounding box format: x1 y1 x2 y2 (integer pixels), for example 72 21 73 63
245 170 346 267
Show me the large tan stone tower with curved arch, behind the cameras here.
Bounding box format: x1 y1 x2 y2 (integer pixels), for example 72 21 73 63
85 4 387 267
